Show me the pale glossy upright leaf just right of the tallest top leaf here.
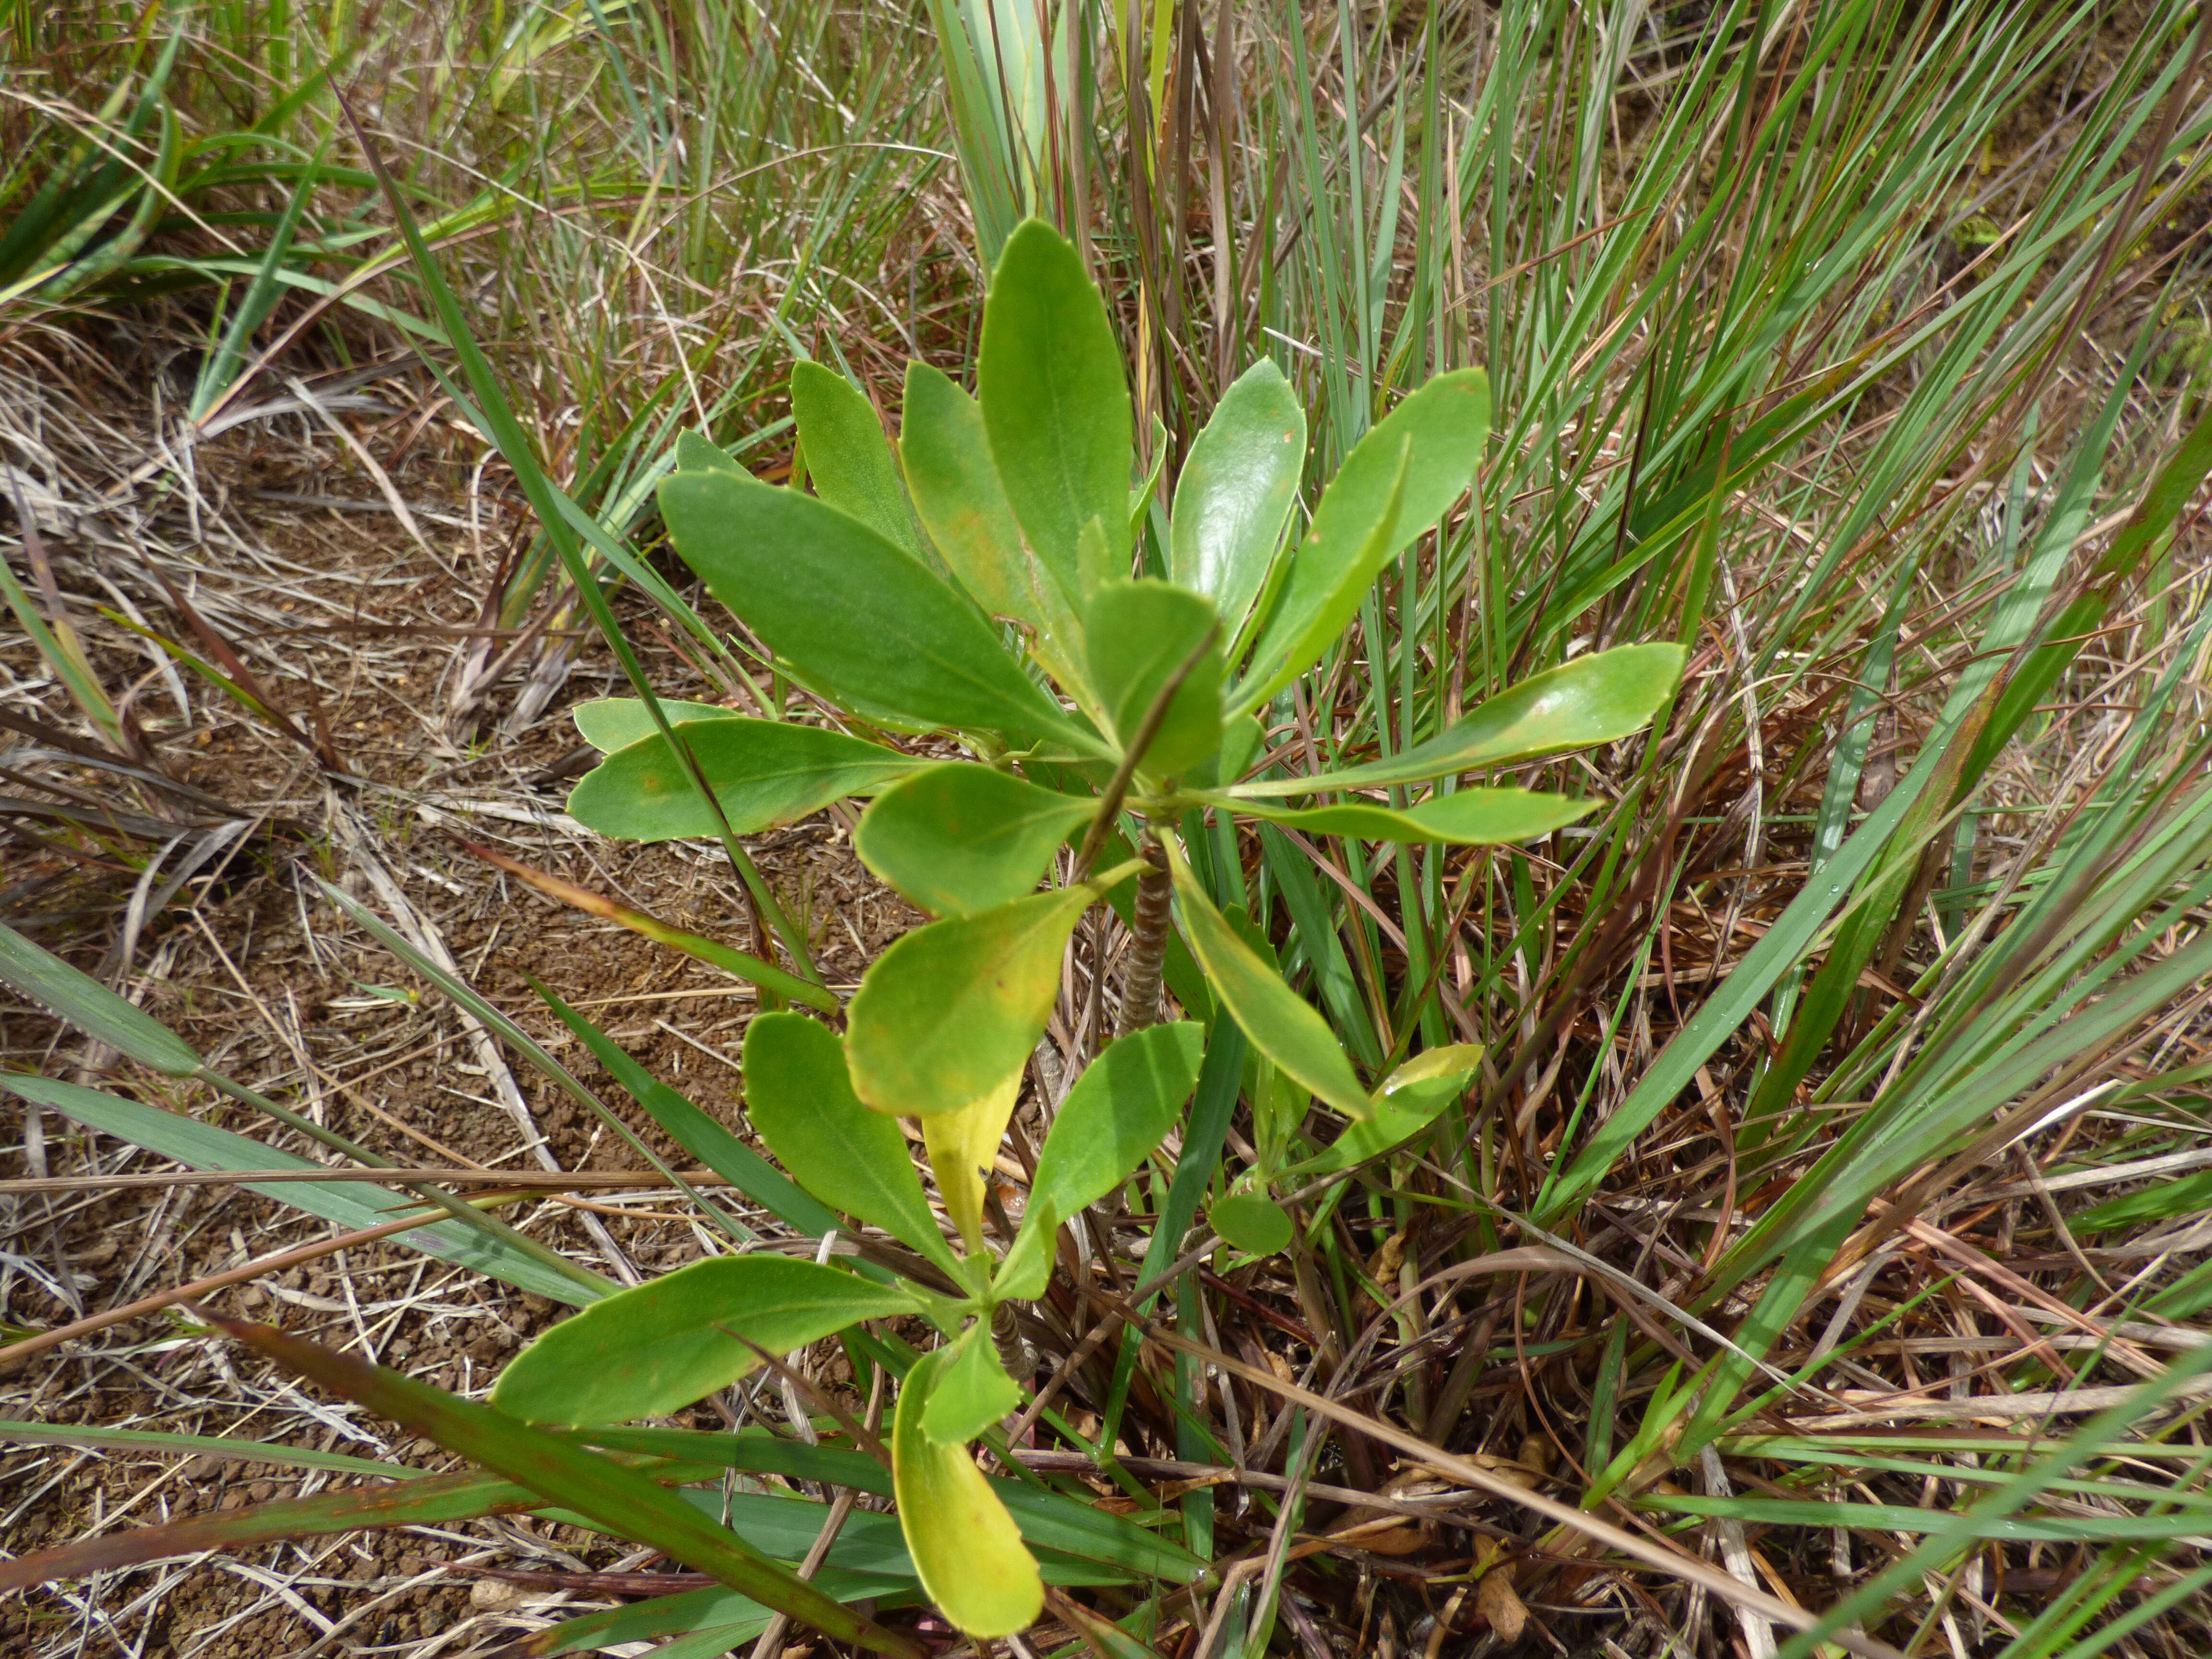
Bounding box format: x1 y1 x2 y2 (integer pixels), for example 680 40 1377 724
1168 358 1305 635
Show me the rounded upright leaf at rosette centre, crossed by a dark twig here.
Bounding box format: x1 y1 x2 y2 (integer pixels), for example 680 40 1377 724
1084 579 1223 776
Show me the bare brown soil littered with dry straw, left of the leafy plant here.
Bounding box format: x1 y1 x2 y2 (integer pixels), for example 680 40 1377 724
0 345 916 1659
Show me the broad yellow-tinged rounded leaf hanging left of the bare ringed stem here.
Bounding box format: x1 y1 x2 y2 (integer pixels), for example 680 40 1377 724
845 887 1097 1117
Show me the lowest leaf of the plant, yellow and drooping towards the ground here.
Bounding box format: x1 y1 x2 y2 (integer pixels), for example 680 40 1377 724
891 1347 1044 1637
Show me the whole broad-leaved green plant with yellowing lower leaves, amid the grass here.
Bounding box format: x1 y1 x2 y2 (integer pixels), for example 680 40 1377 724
530 221 1681 1635
